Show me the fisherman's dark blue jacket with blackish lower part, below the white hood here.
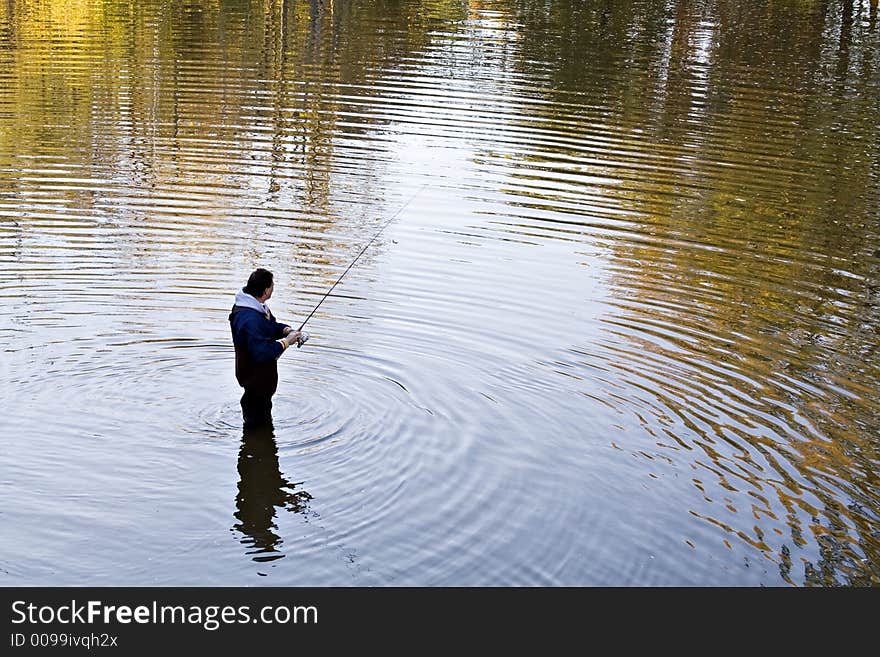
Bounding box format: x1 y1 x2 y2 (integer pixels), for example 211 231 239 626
229 306 287 395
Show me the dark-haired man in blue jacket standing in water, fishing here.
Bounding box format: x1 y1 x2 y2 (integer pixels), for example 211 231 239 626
229 268 308 427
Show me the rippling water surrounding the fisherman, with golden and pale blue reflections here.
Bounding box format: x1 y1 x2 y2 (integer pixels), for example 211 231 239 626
0 0 880 586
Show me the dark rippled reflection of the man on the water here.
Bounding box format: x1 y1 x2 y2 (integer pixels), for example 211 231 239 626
233 424 312 561
